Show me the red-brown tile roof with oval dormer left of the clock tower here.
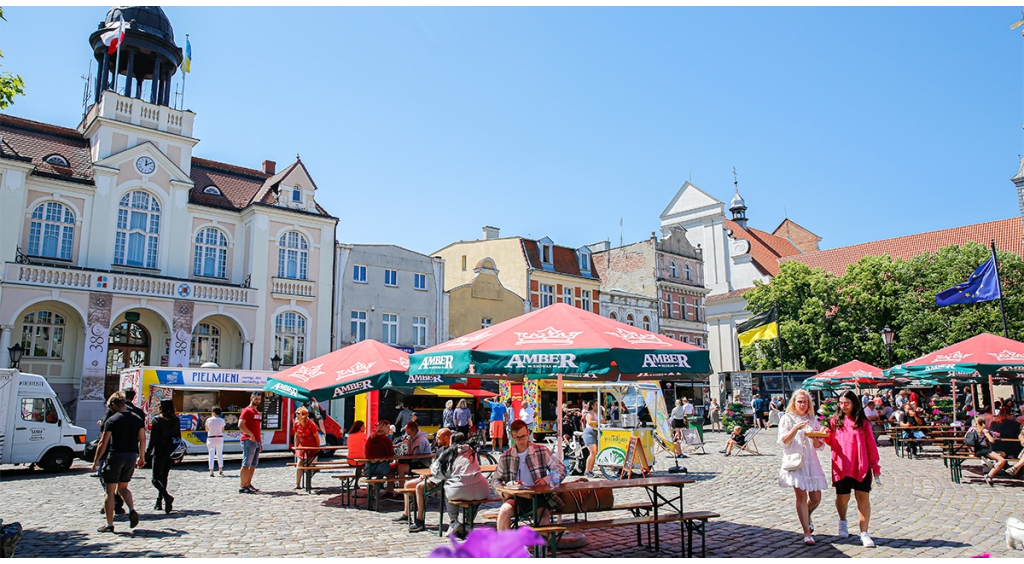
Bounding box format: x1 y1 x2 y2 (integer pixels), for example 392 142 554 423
0 116 92 183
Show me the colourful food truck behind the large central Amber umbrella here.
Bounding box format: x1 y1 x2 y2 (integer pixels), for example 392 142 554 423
499 380 672 478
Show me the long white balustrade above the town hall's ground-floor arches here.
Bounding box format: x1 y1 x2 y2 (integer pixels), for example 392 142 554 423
3 262 256 305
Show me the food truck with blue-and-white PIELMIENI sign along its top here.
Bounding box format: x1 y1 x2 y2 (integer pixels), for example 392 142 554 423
121 366 341 454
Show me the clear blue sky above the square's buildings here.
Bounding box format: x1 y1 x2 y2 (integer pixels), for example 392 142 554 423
0 6 1024 253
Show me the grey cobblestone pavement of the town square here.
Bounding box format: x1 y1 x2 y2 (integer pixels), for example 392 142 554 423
0 429 1024 558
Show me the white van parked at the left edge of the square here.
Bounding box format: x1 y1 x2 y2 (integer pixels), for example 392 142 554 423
0 368 85 472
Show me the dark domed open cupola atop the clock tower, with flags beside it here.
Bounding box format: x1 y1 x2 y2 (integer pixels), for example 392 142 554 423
89 6 184 105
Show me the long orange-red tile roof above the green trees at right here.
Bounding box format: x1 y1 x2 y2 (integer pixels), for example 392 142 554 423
778 217 1024 275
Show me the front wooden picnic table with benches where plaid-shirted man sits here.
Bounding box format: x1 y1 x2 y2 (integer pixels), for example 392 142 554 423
495 476 694 554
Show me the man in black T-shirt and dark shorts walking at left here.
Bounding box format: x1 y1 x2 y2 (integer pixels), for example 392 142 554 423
92 394 145 532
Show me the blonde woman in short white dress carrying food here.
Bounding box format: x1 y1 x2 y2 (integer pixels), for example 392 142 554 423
778 390 828 546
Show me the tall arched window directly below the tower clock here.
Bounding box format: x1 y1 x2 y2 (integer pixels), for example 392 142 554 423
114 191 160 268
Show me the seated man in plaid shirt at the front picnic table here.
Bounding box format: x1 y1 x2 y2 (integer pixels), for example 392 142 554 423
490 419 565 530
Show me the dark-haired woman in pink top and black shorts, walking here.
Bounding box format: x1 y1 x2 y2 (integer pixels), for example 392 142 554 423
824 390 882 548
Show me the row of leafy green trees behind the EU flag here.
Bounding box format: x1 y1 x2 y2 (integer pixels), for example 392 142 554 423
742 243 1024 372
